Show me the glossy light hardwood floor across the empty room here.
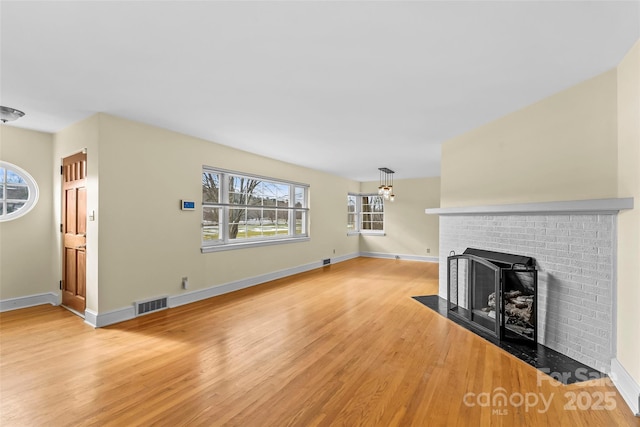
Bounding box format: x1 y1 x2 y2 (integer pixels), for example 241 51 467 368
0 258 640 427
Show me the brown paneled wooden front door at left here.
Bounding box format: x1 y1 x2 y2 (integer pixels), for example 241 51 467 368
62 153 87 314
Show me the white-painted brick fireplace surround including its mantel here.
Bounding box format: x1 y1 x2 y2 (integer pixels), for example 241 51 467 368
426 199 633 372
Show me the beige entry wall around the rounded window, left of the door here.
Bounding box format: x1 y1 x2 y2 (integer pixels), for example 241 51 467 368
0 125 59 300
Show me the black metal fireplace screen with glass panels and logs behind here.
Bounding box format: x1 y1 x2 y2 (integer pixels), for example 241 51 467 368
447 248 538 344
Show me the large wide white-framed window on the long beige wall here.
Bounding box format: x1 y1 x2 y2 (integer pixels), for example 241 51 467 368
202 166 309 252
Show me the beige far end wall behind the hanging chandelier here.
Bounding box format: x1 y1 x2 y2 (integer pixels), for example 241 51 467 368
360 178 440 258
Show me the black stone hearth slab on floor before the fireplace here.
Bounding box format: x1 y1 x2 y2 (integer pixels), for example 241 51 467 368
413 295 606 384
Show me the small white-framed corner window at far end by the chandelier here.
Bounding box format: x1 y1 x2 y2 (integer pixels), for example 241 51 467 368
347 194 384 234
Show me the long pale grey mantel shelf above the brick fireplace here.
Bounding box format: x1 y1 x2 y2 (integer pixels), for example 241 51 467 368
424 197 633 215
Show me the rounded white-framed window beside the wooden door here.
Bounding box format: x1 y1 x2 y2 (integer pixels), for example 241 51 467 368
0 160 38 221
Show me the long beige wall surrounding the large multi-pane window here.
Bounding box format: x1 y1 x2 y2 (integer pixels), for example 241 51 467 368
88 114 359 313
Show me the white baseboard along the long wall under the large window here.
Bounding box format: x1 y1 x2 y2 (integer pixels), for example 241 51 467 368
84 254 358 328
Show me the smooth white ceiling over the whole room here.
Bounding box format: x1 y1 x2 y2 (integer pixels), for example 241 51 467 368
0 1 640 181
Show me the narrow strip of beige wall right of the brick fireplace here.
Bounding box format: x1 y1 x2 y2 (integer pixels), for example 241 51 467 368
616 41 640 384
